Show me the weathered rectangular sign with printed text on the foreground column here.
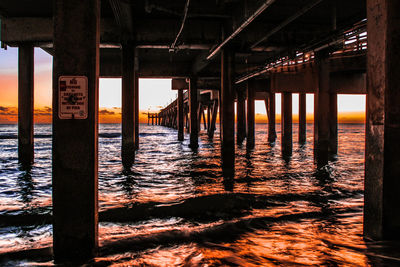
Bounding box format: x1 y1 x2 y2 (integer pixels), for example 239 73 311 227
58 76 88 120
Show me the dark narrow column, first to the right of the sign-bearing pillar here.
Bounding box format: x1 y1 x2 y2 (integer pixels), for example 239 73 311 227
121 42 135 167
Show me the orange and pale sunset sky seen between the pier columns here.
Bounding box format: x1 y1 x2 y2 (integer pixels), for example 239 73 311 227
0 47 365 123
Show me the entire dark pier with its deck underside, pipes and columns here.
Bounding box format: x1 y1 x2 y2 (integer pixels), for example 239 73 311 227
0 0 400 262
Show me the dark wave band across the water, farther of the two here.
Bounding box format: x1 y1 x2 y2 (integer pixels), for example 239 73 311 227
0 190 362 226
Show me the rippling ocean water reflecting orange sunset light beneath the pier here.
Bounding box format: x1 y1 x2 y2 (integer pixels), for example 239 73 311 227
0 124 400 266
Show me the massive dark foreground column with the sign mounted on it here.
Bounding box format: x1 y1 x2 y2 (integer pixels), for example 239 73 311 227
52 0 100 262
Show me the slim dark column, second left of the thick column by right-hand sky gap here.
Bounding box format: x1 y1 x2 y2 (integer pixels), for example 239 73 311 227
281 92 293 156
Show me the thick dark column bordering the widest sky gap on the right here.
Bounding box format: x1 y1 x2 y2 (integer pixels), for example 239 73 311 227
314 54 330 161
